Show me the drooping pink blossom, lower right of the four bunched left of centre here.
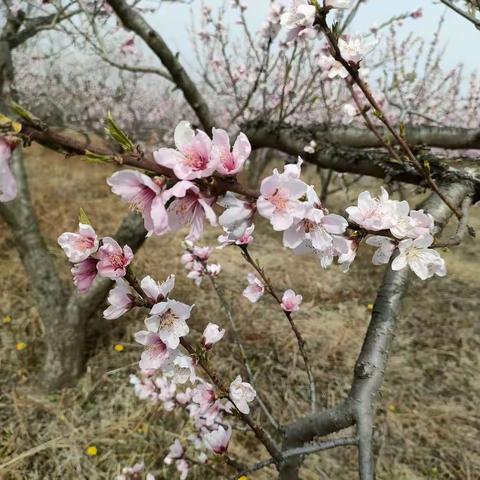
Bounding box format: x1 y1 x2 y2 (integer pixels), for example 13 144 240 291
166 181 217 242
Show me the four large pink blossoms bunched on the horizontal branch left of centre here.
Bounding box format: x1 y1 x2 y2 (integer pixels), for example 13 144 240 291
107 121 251 242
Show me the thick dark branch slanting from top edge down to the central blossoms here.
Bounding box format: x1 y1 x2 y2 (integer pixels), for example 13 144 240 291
107 0 215 132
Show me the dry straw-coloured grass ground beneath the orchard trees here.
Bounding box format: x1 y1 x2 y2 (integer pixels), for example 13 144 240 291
0 147 480 480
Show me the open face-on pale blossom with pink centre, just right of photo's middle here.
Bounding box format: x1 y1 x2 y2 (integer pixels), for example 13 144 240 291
257 171 307 231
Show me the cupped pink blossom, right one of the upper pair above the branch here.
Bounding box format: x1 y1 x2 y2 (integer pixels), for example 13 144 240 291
212 128 252 175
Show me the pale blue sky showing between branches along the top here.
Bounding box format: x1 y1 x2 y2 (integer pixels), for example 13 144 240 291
154 0 480 73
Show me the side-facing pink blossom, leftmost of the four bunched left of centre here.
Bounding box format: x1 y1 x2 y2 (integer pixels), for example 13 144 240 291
107 170 168 235
